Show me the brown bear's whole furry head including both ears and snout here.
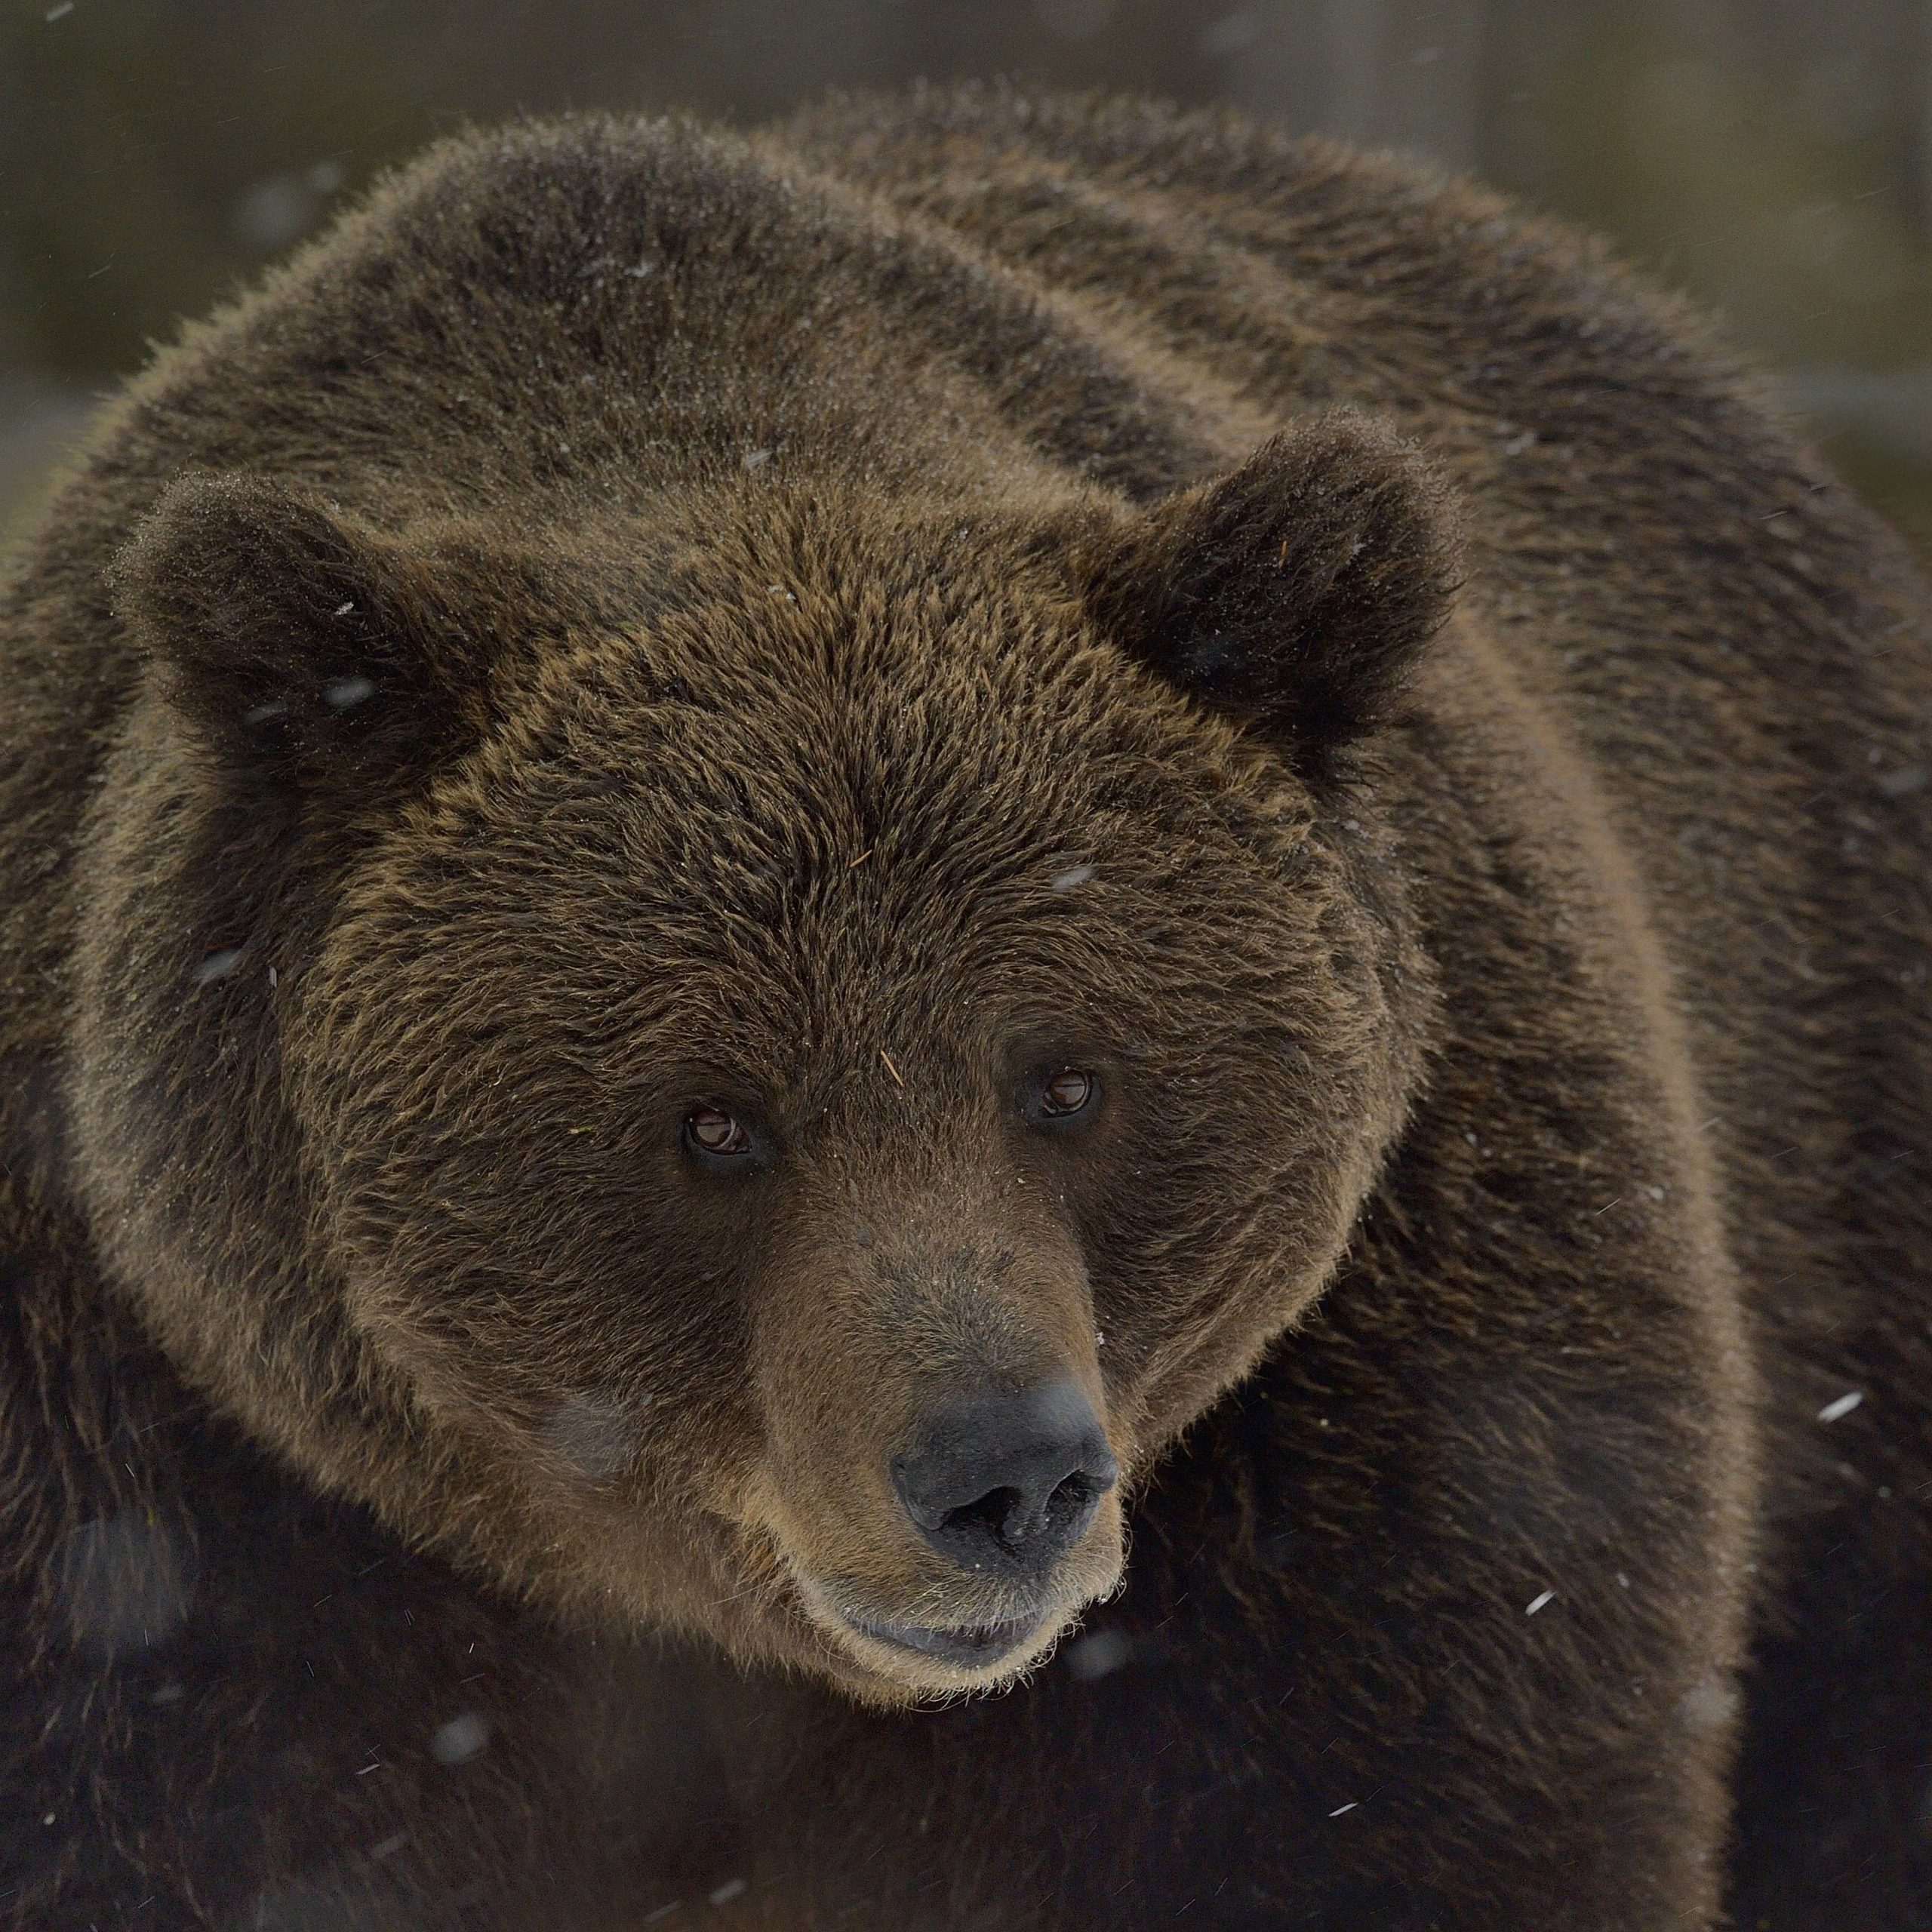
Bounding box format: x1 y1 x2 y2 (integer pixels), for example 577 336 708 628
87 425 1447 1700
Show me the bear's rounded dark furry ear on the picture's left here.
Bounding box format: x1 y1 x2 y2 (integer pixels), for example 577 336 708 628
112 475 498 792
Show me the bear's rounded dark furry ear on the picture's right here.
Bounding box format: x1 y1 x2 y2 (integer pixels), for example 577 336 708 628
1090 411 1457 777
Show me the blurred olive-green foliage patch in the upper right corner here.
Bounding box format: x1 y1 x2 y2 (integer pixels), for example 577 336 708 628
1487 0 1932 363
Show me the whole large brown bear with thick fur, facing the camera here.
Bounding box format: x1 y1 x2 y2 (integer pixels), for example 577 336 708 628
0 89 1932 1932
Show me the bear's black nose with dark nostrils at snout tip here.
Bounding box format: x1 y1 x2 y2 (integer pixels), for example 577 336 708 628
893 1381 1121 1579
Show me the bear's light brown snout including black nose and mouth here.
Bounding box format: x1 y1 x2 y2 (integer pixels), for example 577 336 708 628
740 1213 1132 1697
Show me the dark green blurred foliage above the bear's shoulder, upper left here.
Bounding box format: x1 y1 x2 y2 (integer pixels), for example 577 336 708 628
0 0 1214 383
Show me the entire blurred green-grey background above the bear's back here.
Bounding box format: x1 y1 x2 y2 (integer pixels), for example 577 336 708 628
0 0 1932 546
